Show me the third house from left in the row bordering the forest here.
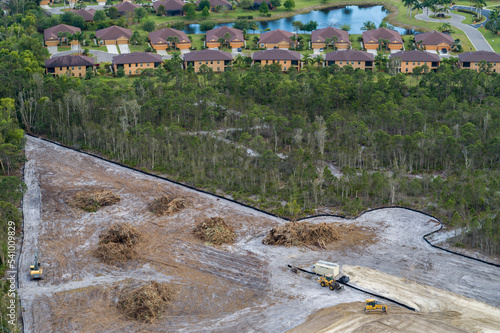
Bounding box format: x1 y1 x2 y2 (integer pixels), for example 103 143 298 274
184 50 233 73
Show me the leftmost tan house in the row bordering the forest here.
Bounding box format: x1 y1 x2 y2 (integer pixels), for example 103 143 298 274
45 55 95 77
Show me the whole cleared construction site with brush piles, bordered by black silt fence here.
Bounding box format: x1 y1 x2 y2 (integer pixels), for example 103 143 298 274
18 137 500 333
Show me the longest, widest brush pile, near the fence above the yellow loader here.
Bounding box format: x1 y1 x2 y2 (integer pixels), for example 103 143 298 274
262 222 373 249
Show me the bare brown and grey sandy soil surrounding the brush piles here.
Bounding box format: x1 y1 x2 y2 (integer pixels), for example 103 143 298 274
19 137 500 332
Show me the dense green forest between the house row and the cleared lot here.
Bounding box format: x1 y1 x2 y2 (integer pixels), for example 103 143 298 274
0 5 500 272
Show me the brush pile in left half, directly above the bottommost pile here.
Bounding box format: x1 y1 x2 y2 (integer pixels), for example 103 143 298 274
94 223 142 264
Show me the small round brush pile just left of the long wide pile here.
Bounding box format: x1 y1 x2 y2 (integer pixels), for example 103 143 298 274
193 217 236 245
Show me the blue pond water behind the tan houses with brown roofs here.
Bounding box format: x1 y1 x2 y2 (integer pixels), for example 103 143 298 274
184 6 413 34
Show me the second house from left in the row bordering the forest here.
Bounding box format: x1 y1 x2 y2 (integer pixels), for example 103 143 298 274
112 52 163 75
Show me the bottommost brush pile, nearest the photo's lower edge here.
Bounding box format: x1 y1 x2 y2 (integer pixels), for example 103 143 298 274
118 281 176 323
